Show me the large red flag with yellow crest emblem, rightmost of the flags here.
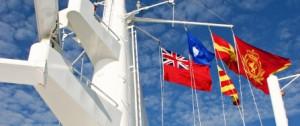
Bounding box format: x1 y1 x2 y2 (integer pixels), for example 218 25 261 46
235 36 291 94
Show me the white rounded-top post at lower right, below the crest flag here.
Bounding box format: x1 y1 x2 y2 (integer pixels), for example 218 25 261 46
267 75 288 126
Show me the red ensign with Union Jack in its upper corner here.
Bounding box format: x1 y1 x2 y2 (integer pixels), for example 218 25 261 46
161 48 212 91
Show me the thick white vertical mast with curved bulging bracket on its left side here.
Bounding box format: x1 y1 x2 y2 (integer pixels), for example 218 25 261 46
92 0 137 126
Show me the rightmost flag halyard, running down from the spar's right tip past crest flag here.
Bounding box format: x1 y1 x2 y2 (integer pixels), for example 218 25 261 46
232 30 263 126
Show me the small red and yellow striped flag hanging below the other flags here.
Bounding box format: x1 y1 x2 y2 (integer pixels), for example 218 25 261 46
218 65 240 105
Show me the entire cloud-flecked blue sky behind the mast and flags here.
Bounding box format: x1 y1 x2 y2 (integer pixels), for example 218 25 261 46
0 0 300 126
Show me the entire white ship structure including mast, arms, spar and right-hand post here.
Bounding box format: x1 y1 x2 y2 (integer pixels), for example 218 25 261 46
0 0 299 126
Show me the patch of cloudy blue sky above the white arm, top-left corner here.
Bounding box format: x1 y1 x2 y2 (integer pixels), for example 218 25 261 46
0 0 36 59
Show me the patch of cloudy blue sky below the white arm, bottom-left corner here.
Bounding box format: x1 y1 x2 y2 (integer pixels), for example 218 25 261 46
0 84 57 126
